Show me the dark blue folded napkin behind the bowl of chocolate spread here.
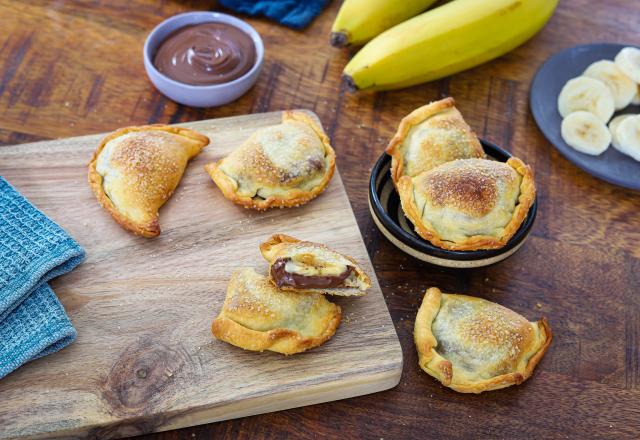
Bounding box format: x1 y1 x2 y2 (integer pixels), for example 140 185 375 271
220 0 328 29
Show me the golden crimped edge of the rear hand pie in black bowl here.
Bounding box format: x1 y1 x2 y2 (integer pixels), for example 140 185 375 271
385 96 464 187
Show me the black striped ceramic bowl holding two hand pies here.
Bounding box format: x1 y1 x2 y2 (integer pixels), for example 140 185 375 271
369 140 538 268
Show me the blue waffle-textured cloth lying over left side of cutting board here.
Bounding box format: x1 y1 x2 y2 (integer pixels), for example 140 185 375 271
0 176 84 378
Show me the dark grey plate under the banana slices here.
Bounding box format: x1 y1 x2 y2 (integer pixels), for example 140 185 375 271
529 43 640 190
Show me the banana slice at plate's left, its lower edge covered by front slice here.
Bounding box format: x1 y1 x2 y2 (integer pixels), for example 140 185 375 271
558 76 615 124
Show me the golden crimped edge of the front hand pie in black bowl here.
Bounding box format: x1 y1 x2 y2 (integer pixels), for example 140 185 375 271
398 157 536 251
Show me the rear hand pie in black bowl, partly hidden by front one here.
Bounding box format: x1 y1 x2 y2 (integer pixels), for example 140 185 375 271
387 98 484 186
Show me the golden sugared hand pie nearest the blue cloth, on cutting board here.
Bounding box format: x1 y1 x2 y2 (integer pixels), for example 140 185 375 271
89 125 209 237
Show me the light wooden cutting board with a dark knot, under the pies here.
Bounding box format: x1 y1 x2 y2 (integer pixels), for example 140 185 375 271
0 112 402 439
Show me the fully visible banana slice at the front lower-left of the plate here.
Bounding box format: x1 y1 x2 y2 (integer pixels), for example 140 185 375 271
560 111 611 156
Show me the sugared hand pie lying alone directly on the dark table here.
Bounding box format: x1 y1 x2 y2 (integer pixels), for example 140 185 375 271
414 287 551 393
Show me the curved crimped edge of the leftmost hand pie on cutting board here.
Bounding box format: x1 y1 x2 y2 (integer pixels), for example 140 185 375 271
88 124 209 238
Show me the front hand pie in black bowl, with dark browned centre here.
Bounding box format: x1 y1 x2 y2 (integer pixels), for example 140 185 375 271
398 157 536 250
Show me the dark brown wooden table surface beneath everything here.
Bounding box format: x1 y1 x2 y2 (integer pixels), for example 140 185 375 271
0 0 640 440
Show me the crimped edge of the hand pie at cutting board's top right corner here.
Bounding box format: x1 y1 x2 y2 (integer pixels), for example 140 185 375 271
204 110 336 211
